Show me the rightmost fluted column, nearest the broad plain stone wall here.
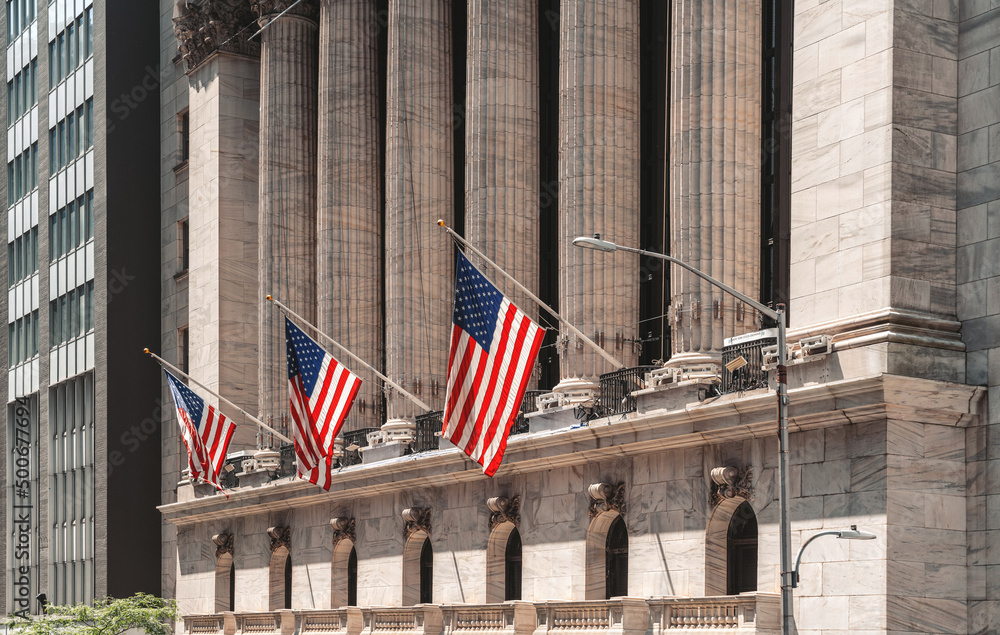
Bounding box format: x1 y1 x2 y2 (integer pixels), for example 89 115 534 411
670 0 761 365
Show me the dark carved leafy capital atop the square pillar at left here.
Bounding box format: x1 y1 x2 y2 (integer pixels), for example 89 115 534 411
174 0 260 72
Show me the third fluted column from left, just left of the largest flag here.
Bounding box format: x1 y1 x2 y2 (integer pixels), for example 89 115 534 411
384 0 455 434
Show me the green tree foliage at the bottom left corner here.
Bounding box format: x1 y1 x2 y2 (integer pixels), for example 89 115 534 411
5 593 177 635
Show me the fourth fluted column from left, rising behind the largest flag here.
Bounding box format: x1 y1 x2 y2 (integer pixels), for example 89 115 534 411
465 0 539 368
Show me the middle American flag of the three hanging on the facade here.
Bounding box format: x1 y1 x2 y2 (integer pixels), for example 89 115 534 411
285 318 361 490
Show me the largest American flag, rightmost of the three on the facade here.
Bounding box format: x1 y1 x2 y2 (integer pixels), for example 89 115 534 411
441 252 545 476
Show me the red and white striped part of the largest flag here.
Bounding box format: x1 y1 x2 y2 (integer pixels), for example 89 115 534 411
442 298 545 476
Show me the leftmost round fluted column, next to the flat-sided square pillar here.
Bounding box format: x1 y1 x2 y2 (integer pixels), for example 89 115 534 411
258 0 317 434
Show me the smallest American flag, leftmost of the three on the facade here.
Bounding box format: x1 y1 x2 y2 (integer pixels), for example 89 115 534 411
163 370 236 490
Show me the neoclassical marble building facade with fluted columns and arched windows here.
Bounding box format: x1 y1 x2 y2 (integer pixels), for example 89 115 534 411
160 0 1000 635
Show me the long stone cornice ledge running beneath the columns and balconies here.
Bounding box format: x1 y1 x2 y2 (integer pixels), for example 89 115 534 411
159 374 985 525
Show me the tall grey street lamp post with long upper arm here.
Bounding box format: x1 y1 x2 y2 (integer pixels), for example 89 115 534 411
573 234 795 635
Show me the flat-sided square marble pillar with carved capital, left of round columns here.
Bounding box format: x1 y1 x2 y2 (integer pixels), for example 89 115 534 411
174 2 260 451
